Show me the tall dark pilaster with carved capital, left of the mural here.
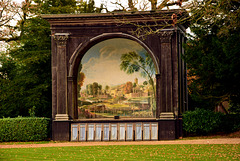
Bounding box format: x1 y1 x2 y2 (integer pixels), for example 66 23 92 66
54 33 69 120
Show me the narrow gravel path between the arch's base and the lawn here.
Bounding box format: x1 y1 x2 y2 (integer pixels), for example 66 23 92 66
0 138 240 148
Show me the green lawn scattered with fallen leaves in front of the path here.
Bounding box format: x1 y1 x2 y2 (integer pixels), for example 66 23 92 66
0 144 240 161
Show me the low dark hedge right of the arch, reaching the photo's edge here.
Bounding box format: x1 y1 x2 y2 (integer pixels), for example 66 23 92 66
183 108 240 135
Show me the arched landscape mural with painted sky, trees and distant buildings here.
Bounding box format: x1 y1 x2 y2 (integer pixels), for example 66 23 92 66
78 38 156 119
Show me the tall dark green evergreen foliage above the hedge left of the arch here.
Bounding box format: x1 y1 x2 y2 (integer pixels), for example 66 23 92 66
0 17 51 117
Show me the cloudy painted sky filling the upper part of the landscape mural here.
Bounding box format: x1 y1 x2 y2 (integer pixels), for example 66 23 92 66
81 38 146 89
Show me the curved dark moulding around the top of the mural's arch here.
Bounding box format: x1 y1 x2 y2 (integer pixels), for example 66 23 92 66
68 32 160 77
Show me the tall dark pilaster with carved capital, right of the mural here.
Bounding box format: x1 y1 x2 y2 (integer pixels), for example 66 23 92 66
159 31 174 119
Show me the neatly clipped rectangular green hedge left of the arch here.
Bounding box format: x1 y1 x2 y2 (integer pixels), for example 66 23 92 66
0 117 50 142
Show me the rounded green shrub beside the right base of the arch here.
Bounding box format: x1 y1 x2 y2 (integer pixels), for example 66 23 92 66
183 108 224 135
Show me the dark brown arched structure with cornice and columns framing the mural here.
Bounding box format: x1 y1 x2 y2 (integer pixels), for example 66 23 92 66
42 10 187 140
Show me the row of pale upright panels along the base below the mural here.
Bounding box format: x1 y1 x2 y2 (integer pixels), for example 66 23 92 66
71 122 158 141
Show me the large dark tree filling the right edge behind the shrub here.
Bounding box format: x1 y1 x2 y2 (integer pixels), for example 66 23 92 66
184 0 240 112
